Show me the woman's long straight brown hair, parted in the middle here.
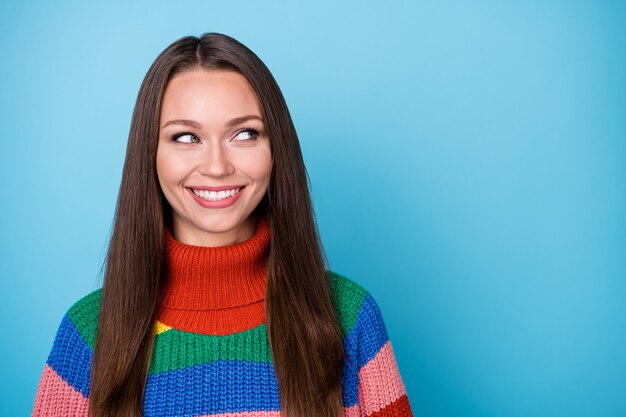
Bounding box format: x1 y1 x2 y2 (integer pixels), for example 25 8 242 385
89 33 344 417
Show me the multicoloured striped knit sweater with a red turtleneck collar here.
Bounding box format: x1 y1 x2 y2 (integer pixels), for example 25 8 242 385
32 217 412 417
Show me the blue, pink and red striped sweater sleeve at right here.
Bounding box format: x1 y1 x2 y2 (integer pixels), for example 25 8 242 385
356 293 413 417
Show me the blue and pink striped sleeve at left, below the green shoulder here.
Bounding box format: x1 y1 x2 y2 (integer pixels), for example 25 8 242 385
32 313 92 417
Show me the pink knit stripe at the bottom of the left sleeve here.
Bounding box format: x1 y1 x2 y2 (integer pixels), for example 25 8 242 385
32 364 89 417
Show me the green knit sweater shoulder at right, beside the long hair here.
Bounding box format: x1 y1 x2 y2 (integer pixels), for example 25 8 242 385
326 270 374 334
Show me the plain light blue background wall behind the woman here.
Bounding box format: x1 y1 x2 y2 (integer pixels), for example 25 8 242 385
0 0 626 417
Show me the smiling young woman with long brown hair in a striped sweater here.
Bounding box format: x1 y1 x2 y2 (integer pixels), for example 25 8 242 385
33 33 412 417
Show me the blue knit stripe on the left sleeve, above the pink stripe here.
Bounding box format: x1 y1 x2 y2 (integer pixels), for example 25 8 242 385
47 314 92 397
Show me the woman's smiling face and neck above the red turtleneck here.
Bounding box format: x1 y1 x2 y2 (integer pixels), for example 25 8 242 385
156 69 272 246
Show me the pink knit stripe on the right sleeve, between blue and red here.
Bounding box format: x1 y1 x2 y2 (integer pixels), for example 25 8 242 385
359 341 406 416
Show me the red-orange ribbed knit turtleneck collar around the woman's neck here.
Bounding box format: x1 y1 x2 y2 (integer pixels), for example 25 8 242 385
158 216 270 335
